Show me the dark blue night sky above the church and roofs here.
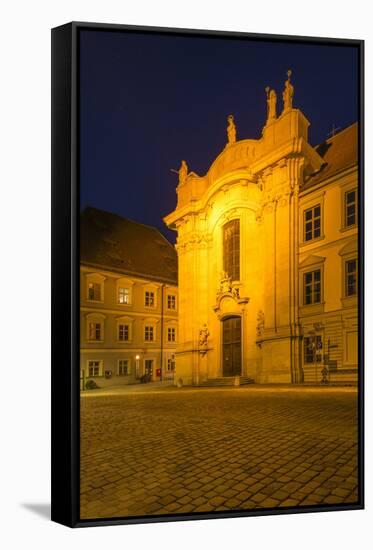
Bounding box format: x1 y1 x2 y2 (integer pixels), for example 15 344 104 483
80 30 358 241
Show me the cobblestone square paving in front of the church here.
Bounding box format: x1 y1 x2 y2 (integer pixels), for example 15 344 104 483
81 386 357 518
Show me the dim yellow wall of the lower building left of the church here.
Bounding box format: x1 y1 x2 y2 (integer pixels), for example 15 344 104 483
80 265 179 387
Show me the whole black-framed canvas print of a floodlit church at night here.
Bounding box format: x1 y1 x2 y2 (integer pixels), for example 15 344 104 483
52 23 364 527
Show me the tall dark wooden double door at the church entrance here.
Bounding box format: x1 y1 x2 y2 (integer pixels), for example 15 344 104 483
222 316 242 376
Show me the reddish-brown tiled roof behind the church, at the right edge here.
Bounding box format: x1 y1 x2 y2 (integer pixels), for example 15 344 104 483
303 122 358 189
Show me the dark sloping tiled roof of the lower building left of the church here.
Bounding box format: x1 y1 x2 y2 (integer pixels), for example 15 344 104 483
80 207 177 284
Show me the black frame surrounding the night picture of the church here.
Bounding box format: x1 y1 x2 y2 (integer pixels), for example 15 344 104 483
51 22 364 527
